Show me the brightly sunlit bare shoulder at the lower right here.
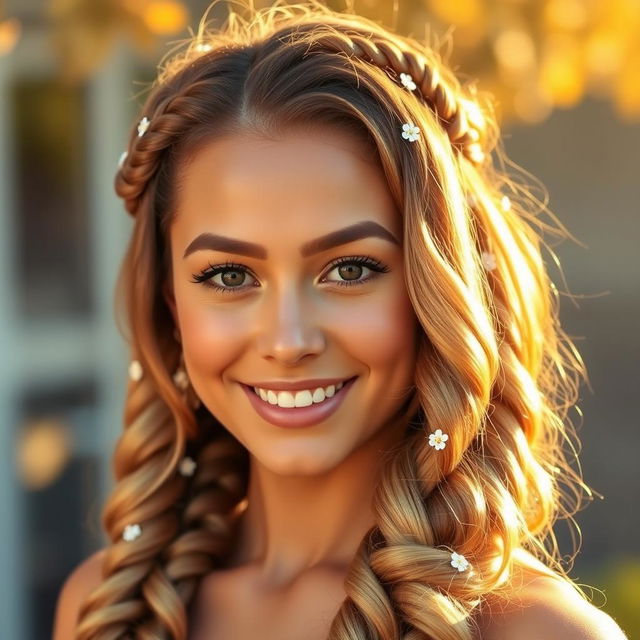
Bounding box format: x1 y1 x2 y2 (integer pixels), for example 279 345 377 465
476 552 628 640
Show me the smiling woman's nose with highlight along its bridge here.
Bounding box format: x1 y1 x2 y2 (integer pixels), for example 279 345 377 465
257 286 325 365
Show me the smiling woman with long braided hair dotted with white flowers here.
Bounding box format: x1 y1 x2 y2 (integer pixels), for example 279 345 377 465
54 2 624 640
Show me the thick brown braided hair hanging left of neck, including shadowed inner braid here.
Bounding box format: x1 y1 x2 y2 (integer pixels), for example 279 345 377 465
76 350 247 640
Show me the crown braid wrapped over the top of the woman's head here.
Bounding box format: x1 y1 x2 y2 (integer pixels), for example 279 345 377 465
115 20 487 215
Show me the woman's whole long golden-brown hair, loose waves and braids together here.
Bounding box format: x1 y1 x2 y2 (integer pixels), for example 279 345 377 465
76 0 591 640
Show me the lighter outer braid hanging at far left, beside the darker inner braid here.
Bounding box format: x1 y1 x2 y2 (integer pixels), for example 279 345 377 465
75 378 185 640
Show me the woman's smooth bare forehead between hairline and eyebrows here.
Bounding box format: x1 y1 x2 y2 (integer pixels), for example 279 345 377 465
172 128 402 244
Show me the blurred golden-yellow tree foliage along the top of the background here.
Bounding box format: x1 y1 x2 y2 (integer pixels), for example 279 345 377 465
0 0 640 123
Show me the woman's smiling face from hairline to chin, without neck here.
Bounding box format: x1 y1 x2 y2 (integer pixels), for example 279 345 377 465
164 129 418 475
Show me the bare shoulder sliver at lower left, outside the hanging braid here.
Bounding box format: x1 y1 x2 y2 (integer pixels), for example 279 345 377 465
53 549 105 640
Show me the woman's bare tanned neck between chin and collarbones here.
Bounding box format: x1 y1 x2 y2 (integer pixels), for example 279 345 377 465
230 421 406 587
